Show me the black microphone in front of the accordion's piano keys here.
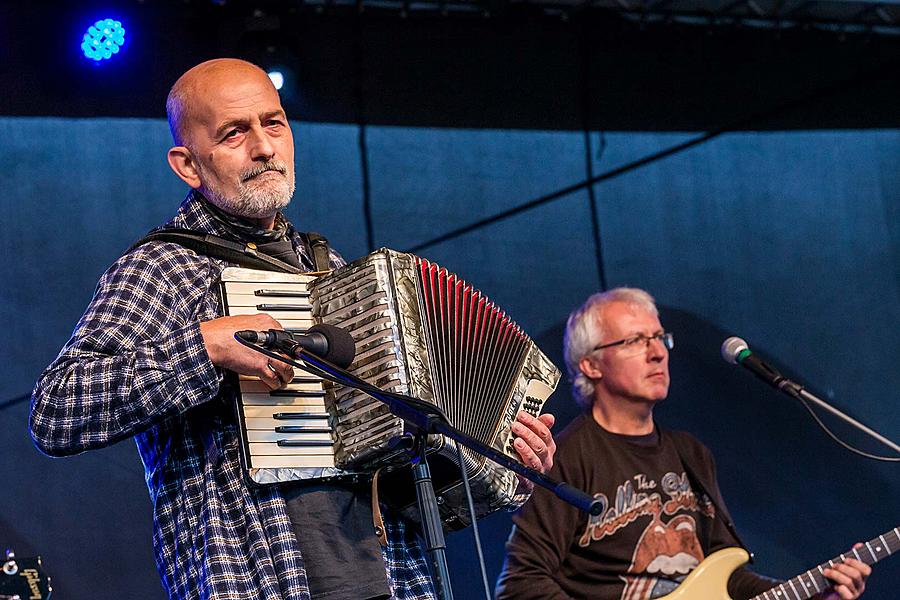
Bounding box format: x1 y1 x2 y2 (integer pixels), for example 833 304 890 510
234 323 356 369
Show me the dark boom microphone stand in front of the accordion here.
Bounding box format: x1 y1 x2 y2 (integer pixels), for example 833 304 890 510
235 336 603 600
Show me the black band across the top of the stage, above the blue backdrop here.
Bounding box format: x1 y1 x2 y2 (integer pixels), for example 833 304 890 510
0 2 900 131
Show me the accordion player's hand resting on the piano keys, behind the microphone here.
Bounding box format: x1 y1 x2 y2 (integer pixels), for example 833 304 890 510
200 314 294 390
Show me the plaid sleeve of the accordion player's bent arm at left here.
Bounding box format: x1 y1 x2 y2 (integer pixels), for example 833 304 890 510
29 244 219 456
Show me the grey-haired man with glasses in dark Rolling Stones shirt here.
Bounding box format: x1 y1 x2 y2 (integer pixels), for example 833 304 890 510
497 288 870 600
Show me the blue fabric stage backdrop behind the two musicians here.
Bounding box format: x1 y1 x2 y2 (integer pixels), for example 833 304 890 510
0 118 900 600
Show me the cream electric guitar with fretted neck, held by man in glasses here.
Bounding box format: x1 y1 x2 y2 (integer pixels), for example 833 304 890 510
659 527 900 600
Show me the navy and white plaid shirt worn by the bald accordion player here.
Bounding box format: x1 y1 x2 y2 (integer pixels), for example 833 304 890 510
29 194 434 600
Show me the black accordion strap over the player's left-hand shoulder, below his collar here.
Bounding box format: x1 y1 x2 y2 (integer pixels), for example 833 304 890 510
128 228 306 273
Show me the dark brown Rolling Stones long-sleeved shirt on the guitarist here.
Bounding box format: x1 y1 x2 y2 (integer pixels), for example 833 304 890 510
497 414 774 600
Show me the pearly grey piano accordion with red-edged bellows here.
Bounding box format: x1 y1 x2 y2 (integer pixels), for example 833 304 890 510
222 249 560 529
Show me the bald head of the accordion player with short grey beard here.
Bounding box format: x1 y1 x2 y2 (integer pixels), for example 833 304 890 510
166 58 294 228
